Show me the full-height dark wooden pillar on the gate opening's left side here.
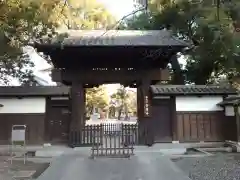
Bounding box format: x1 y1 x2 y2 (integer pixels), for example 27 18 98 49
70 82 85 146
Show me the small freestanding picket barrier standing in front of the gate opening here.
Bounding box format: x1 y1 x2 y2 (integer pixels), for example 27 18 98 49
91 124 137 158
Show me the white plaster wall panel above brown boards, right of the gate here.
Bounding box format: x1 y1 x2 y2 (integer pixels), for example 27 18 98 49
176 96 223 111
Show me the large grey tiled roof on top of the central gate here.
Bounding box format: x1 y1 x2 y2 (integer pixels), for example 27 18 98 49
49 30 189 47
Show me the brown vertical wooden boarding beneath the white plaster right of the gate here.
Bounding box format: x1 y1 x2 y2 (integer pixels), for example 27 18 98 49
177 111 237 142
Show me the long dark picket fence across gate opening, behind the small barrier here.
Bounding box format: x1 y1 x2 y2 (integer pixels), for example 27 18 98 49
69 123 138 147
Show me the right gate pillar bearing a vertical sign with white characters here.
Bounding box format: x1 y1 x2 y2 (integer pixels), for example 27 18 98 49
137 79 153 144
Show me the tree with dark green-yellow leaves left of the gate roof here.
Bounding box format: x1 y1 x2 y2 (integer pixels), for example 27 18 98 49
0 0 63 84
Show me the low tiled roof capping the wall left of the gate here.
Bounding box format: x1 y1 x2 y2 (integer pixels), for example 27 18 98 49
0 86 69 97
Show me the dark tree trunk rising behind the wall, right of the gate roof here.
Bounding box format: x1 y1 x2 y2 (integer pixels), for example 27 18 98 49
170 55 184 85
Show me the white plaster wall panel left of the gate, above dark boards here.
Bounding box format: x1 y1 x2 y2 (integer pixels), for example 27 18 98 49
0 97 46 113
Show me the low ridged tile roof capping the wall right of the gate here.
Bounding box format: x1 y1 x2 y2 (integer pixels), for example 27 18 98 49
151 85 237 95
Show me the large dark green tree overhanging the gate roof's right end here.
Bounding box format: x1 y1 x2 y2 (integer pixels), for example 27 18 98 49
122 0 240 84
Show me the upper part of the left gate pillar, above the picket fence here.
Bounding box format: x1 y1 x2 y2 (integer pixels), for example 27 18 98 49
70 82 85 131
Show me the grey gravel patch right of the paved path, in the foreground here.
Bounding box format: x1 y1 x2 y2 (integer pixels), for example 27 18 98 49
173 153 240 180
